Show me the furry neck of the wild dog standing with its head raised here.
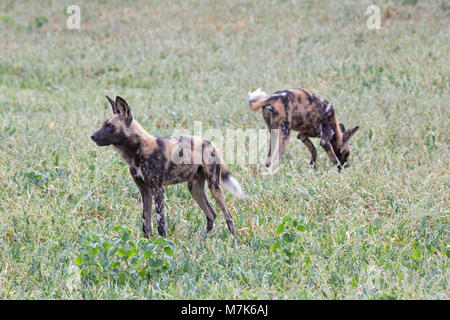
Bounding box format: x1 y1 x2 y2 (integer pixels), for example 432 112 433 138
114 120 156 166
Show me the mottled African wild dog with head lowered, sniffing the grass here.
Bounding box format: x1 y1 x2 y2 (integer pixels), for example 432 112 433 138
249 88 359 170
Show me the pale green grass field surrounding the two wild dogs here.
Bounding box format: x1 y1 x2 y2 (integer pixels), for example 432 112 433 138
0 0 450 299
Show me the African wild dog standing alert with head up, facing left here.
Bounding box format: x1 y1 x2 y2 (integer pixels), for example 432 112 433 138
91 96 244 237
